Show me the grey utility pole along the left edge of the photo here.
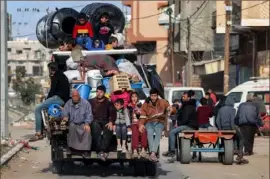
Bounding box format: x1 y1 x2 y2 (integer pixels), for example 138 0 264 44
0 1 9 138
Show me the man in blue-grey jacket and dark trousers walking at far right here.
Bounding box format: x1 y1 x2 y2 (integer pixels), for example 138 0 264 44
235 94 263 155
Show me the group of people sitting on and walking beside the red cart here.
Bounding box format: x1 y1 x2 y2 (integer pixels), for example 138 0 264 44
163 91 266 164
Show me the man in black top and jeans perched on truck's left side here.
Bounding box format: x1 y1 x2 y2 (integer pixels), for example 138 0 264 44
30 62 70 142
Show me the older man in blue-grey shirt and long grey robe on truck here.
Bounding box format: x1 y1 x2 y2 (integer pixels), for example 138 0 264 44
63 90 93 157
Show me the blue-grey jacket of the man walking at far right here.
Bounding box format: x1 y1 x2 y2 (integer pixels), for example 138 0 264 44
235 101 263 127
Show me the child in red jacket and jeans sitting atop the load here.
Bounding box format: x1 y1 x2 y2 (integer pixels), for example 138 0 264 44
72 13 94 50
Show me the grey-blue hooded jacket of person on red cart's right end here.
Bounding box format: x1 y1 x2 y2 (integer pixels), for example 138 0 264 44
216 97 236 130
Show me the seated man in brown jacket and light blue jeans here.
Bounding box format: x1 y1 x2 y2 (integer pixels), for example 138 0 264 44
139 88 170 162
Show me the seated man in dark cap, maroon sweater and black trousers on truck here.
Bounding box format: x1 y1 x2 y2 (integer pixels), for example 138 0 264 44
90 85 116 161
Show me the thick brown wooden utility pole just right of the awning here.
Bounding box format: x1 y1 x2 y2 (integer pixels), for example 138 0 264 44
223 0 232 94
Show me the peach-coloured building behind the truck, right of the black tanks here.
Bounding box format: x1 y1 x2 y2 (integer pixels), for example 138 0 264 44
122 1 180 85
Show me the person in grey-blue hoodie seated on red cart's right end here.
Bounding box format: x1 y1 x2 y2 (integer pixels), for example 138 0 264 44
216 97 248 164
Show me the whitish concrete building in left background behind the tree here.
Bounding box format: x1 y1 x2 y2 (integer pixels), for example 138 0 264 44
8 38 51 76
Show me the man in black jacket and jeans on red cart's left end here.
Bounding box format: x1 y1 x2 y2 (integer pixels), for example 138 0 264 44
169 93 198 159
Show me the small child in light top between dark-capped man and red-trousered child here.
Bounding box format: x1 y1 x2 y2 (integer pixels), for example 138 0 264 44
114 98 131 153
